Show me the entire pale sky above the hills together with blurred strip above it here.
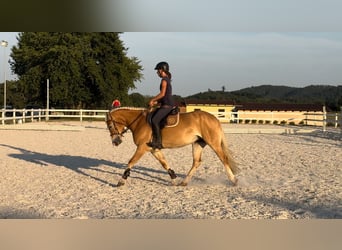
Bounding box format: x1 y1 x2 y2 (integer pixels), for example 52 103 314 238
0 0 342 97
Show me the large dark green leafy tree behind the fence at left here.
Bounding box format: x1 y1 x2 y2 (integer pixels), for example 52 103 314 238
11 32 142 108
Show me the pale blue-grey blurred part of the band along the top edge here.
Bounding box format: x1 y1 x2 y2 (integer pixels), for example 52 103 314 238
97 0 342 32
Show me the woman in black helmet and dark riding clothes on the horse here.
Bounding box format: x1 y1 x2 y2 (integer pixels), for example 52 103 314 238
147 62 175 149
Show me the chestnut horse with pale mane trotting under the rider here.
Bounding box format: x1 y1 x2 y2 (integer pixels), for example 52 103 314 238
106 107 239 187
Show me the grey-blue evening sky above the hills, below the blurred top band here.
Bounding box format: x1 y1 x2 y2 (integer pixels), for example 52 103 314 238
0 32 342 97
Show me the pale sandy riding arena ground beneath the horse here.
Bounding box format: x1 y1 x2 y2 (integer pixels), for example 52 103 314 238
0 122 342 219
